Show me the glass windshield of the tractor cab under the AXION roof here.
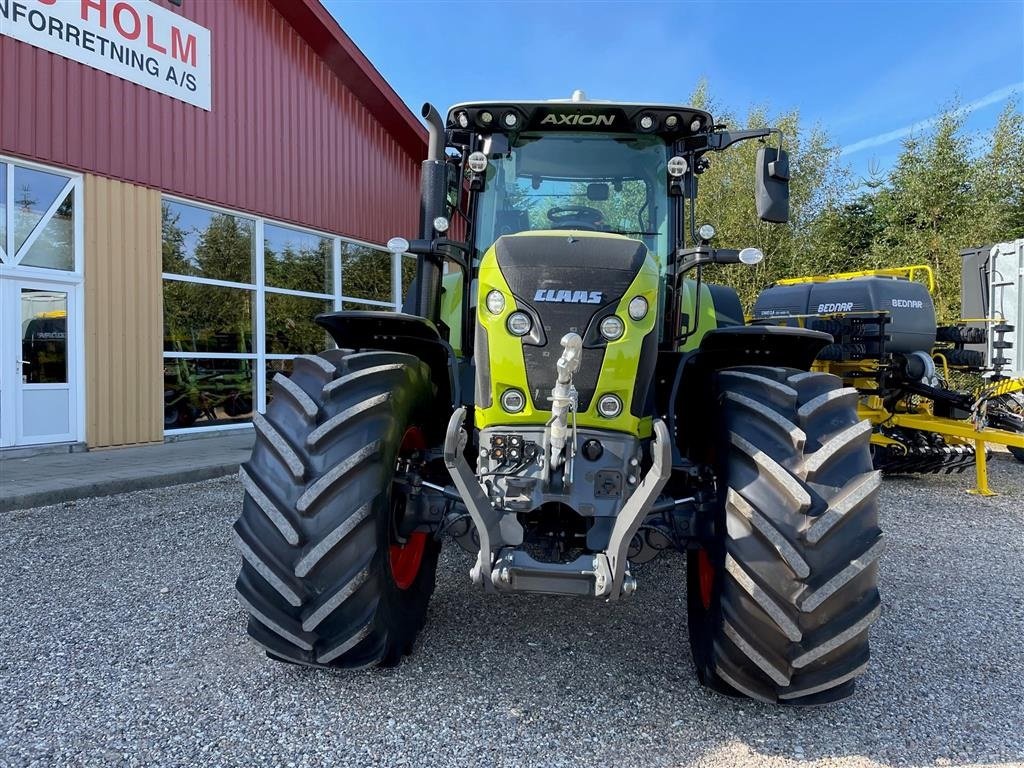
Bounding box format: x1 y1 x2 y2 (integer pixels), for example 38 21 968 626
474 133 669 270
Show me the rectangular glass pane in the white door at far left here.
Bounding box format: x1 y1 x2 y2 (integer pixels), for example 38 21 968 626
22 288 68 384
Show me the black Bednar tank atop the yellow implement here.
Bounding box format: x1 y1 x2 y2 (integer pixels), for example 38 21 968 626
754 276 935 353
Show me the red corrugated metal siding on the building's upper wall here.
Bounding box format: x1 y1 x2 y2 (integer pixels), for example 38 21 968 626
0 0 425 243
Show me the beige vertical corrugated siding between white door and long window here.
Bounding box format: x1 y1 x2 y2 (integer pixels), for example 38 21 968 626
84 175 164 447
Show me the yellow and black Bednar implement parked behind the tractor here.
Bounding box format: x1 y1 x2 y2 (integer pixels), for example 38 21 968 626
752 264 1024 496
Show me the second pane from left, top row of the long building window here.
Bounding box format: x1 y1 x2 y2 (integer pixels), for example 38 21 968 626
263 224 334 294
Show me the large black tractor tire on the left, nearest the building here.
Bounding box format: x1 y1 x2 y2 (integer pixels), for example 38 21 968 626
234 349 439 668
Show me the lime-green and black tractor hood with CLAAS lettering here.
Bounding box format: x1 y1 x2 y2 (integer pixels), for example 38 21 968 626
476 229 658 436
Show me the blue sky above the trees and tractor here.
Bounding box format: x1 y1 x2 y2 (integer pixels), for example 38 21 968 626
324 0 1024 182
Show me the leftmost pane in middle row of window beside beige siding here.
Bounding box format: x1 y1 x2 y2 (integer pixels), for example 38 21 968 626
164 280 254 352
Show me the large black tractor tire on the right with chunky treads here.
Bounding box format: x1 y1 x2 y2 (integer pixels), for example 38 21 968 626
687 367 883 705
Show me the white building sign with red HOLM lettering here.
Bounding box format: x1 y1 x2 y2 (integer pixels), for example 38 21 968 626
0 0 210 110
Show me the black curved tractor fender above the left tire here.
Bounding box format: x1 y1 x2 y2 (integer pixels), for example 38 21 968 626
315 311 464 424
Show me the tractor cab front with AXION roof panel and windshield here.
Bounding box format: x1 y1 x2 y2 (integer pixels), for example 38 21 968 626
456 92 711 269
